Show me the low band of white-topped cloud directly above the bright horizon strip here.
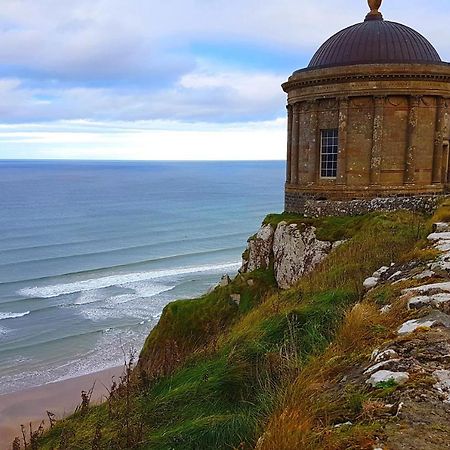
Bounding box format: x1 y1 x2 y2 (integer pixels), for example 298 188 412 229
0 62 284 123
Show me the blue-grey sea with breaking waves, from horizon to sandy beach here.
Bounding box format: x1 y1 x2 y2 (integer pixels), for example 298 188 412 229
0 161 285 394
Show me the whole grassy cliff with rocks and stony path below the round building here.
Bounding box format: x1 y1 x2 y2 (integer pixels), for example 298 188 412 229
35 204 450 450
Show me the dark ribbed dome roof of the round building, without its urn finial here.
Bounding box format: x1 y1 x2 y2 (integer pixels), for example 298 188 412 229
308 20 441 68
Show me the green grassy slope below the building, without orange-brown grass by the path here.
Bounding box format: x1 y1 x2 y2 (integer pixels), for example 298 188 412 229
39 212 428 450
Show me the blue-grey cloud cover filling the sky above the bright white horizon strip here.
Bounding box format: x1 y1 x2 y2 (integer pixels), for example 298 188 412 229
0 0 450 133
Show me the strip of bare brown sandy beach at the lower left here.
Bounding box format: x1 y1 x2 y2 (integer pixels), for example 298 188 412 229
0 366 124 450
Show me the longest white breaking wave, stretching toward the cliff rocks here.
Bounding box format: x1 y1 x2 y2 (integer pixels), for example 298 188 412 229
18 263 240 298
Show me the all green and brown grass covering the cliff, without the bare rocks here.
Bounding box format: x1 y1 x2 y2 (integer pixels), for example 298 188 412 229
32 206 447 450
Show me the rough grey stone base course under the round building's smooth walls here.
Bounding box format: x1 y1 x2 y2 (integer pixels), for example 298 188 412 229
285 192 446 217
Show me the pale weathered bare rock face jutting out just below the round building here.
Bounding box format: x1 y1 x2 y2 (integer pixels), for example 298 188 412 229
240 221 334 289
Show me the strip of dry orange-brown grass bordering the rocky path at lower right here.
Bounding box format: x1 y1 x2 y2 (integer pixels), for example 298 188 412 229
258 303 407 450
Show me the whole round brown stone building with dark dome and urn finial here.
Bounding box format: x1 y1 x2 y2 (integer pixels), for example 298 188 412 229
283 0 450 215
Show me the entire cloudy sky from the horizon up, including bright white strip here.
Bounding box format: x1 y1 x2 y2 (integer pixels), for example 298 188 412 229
0 0 450 160
